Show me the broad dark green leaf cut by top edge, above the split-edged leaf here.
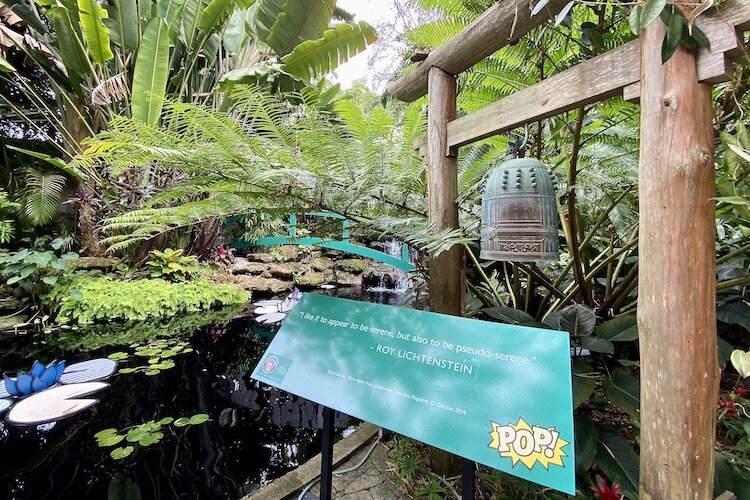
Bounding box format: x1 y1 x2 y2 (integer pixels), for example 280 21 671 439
258 0 336 56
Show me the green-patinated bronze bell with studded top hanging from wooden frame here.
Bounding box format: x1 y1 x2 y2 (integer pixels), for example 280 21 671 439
479 158 559 262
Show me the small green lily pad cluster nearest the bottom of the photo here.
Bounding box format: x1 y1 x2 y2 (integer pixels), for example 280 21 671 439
94 413 209 460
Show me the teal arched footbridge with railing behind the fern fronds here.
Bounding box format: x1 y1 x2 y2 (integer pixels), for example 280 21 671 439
227 212 415 272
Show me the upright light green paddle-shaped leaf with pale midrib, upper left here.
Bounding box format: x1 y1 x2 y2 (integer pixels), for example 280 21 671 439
131 18 169 125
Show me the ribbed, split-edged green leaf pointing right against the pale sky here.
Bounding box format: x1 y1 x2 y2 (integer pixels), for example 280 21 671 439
282 21 378 80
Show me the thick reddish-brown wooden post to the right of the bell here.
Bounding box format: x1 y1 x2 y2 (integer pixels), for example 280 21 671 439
638 12 719 500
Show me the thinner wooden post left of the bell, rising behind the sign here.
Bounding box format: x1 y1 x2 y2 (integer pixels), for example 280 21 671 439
427 68 464 316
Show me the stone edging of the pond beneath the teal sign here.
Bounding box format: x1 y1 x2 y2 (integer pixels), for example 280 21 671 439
240 422 380 500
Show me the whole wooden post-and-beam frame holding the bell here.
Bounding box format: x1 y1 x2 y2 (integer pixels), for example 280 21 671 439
387 0 750 499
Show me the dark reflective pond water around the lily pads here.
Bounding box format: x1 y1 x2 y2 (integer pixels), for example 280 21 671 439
0 290 412 500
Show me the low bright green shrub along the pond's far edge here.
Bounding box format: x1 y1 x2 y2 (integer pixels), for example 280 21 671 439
50 276 250 324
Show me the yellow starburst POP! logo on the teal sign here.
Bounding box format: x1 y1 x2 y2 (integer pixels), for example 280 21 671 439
489 418 568 470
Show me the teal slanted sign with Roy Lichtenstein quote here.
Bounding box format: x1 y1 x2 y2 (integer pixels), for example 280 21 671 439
252 293 575 495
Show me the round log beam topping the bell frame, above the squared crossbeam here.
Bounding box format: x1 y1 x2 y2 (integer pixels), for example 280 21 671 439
386 0 568 102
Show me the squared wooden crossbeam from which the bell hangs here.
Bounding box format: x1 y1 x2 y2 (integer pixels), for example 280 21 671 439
414 0 750 154
